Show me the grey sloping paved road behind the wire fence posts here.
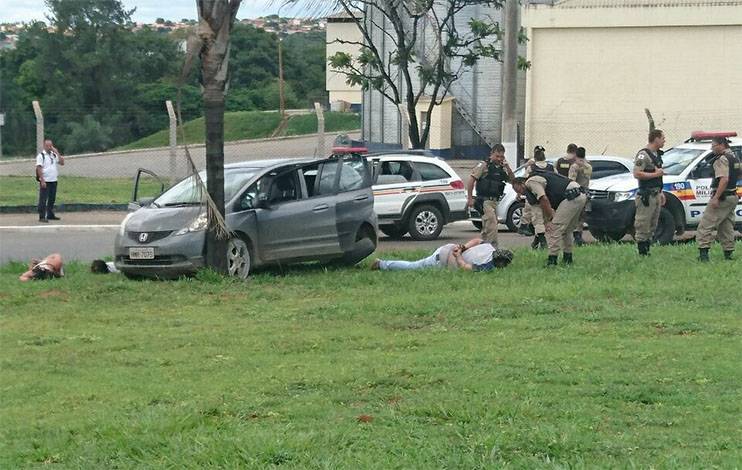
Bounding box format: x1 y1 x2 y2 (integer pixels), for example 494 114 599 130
0 133 361 178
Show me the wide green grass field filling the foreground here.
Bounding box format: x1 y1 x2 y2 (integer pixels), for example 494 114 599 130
0 244 742 469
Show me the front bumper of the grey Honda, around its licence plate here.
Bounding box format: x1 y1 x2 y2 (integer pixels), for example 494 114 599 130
114 231 206 279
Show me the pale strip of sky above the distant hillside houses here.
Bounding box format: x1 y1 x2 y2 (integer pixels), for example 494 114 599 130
0 0 316 23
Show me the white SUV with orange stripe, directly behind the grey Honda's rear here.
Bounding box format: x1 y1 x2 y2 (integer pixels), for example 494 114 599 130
366 150 468 240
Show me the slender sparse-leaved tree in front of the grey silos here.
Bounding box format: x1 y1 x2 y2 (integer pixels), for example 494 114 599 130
328 0 528 148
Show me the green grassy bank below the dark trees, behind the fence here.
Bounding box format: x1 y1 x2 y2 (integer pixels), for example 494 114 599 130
115 111 361 150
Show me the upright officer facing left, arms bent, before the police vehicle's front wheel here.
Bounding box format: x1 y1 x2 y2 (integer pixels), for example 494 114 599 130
634 129 665 256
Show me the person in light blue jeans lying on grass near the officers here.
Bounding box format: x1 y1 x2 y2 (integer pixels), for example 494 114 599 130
371 238 513 271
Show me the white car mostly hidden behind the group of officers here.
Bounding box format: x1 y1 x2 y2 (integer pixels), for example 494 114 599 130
471 155 633 232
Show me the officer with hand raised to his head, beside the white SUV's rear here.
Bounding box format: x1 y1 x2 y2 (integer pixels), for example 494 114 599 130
466 144 514 245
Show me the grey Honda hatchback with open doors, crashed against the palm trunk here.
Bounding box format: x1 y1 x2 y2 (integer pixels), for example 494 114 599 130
114 154 378 278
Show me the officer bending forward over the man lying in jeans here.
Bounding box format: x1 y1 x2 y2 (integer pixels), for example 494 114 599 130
513 170 587 266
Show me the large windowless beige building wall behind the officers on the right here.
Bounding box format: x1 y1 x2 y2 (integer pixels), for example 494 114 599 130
523 0 742 156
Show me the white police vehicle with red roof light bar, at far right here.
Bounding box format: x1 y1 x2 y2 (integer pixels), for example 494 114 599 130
587 132 742 244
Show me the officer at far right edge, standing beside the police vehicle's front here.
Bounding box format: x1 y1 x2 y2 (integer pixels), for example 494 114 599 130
696 137 742 261
